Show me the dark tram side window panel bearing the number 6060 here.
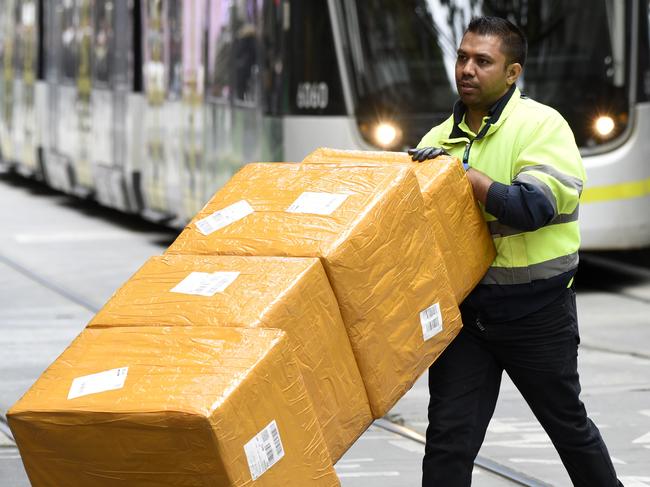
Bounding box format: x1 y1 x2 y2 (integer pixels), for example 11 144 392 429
289 0 345 115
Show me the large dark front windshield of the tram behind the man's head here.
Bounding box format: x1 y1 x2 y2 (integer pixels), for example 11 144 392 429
341 0 630 148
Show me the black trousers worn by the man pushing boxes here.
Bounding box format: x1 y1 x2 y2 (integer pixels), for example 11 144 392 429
422 289 622 487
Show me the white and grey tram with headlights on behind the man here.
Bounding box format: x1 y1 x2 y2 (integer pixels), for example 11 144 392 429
0 0 650 249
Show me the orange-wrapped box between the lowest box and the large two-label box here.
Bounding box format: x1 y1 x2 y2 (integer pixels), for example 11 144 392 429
89 255 372 462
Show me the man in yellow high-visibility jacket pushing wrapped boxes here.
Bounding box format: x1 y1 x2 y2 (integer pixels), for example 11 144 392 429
409 17 622 487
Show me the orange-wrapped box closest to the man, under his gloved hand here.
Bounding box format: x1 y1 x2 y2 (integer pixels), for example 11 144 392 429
303 147 496 303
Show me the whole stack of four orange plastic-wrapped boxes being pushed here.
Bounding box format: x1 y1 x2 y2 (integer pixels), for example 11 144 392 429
8 149 493 486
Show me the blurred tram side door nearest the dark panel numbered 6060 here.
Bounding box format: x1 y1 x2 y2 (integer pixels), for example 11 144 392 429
204 0 276 200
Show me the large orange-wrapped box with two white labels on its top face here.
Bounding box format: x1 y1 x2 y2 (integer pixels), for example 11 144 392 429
167 163 461 417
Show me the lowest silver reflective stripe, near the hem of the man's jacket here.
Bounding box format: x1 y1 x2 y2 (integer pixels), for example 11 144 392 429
481 252 578 285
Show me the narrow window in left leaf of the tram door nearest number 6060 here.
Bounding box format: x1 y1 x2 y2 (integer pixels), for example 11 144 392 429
206 0 232 100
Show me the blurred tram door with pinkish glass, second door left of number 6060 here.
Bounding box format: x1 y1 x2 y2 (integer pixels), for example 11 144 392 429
141 0 200 223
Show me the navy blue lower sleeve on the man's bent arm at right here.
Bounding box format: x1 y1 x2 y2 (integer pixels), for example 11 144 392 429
485 181 555 232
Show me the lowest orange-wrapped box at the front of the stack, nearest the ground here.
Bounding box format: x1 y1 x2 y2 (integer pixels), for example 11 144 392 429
7 327 339 487
